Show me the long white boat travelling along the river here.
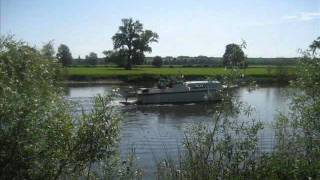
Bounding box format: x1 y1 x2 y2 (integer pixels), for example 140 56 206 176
136 81 222 104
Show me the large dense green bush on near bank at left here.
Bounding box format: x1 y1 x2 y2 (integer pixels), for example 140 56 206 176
0 37 140 179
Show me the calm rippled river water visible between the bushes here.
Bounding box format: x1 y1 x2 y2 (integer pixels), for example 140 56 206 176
67 85 288 179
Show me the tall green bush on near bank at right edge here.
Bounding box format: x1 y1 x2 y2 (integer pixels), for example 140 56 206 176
259 39 320 179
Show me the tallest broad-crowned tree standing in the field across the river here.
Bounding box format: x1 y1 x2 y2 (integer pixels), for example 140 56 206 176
112 18 159 69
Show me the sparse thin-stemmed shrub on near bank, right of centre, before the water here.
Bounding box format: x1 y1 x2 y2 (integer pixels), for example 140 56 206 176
157 68 262 179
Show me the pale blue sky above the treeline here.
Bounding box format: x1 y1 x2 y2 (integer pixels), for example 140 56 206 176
0 0 320 57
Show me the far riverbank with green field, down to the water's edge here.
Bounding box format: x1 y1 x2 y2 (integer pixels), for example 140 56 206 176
65 66 295 84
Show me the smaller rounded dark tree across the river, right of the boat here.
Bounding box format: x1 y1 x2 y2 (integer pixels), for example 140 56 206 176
223 42 246 67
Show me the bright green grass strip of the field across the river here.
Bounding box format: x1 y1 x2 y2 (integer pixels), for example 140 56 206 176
67 66 294 79
